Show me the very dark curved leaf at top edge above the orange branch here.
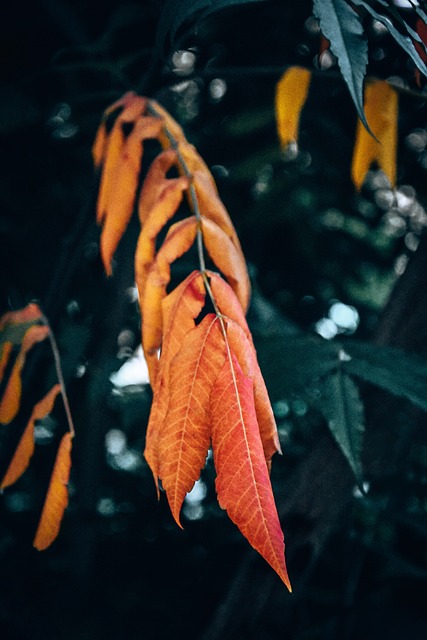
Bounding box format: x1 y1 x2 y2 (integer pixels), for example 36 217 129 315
156 0 265 55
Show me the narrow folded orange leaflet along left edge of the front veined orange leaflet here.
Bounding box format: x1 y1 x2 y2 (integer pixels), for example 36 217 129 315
144 271 205 485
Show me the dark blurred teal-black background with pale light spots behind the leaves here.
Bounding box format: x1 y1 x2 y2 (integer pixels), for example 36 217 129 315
0 0 427 640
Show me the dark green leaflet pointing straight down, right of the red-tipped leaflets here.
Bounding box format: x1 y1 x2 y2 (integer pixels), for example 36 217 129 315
319 367 365 485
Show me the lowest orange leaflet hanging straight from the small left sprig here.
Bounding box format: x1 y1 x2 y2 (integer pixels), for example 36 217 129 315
33 432 72 551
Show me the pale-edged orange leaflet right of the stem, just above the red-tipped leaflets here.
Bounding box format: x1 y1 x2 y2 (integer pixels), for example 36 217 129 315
202 218 251 311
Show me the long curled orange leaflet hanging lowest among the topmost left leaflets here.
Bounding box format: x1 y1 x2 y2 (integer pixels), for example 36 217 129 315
100 116 161 275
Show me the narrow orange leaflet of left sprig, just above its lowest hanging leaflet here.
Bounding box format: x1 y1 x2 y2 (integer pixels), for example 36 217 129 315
0 384 61 489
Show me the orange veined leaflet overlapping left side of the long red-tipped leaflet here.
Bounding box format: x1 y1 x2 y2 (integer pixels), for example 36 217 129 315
159 314 225 526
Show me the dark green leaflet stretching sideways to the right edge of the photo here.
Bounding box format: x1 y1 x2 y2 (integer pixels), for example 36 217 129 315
343 342 427 411
